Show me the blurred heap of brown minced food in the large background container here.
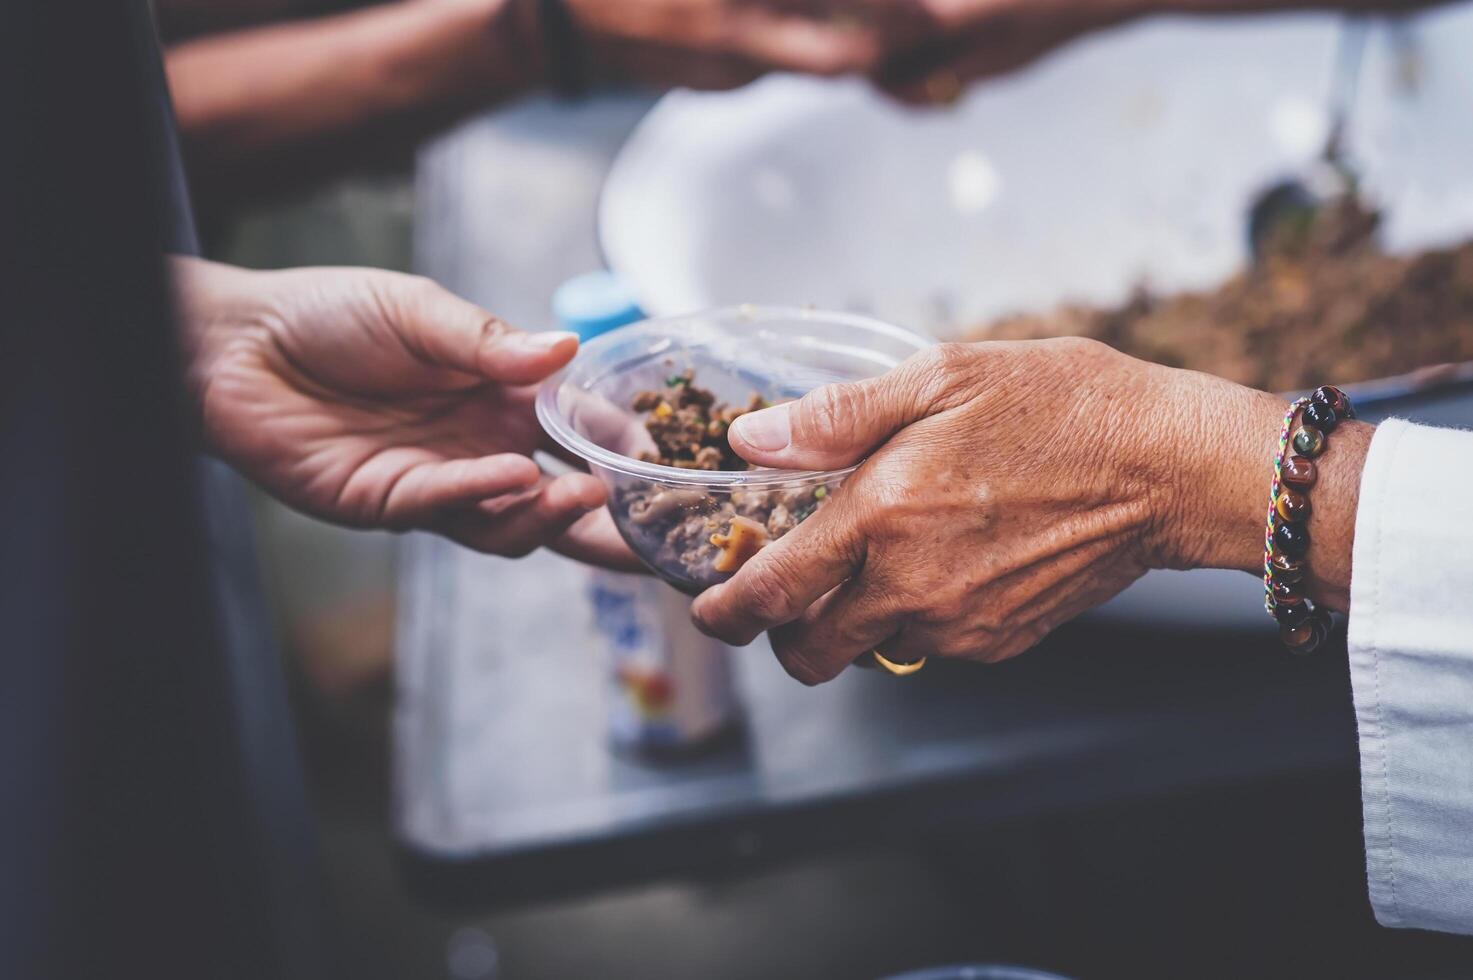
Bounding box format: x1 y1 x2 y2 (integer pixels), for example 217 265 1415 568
968 197 1473 391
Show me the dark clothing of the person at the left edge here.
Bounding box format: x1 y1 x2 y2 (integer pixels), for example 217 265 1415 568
0 0 324 980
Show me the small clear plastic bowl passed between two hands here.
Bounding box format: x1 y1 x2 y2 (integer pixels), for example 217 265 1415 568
538 305 931 595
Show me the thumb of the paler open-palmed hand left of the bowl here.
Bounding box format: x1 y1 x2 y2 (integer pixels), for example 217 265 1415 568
395 279 577 385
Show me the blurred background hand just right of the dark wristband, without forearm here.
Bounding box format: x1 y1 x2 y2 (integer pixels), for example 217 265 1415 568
564 0 931 88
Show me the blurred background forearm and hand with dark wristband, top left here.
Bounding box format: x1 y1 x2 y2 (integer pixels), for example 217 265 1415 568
158 0 928 205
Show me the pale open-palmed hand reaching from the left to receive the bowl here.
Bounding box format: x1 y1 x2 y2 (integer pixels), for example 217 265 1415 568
172 259 633 567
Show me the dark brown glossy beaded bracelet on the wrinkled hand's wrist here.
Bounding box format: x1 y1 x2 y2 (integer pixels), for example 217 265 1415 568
1264 385 1355 653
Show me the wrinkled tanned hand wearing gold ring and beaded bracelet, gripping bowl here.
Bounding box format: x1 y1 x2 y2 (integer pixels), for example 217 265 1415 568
694 339 1368 684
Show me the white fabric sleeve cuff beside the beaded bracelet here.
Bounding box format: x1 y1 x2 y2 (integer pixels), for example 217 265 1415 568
1349 420 1473 933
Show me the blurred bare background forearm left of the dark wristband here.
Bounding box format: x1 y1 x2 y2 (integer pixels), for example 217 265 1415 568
166 0 539 204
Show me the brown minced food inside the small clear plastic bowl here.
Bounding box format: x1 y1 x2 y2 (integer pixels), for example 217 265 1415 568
613 371 829 588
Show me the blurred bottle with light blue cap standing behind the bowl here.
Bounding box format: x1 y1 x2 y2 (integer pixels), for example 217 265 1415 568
552 271 741 755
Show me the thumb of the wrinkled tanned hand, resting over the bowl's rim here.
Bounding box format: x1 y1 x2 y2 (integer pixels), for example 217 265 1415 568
728 370 925 470
